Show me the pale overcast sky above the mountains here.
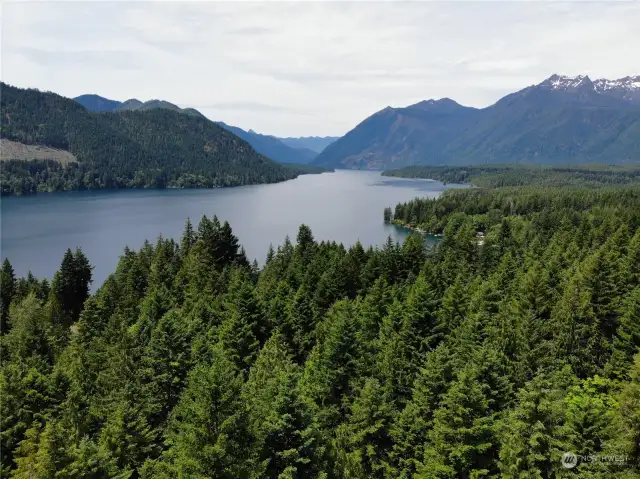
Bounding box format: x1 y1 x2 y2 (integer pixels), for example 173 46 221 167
0 0 640 136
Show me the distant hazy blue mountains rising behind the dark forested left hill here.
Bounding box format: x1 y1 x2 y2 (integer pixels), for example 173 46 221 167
74 94 337 165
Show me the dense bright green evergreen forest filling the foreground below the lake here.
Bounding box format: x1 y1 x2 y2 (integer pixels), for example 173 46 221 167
0 179 640 479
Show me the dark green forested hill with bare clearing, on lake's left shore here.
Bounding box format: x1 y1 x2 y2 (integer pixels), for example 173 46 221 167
0 84 300 194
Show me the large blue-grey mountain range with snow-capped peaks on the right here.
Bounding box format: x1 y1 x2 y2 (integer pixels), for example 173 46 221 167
313 75 640 169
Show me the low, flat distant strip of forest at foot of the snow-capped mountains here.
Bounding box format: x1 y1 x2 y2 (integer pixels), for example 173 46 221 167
382 165 640 188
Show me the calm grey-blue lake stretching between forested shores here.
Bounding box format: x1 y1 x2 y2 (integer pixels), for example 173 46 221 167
0 170 456 289
